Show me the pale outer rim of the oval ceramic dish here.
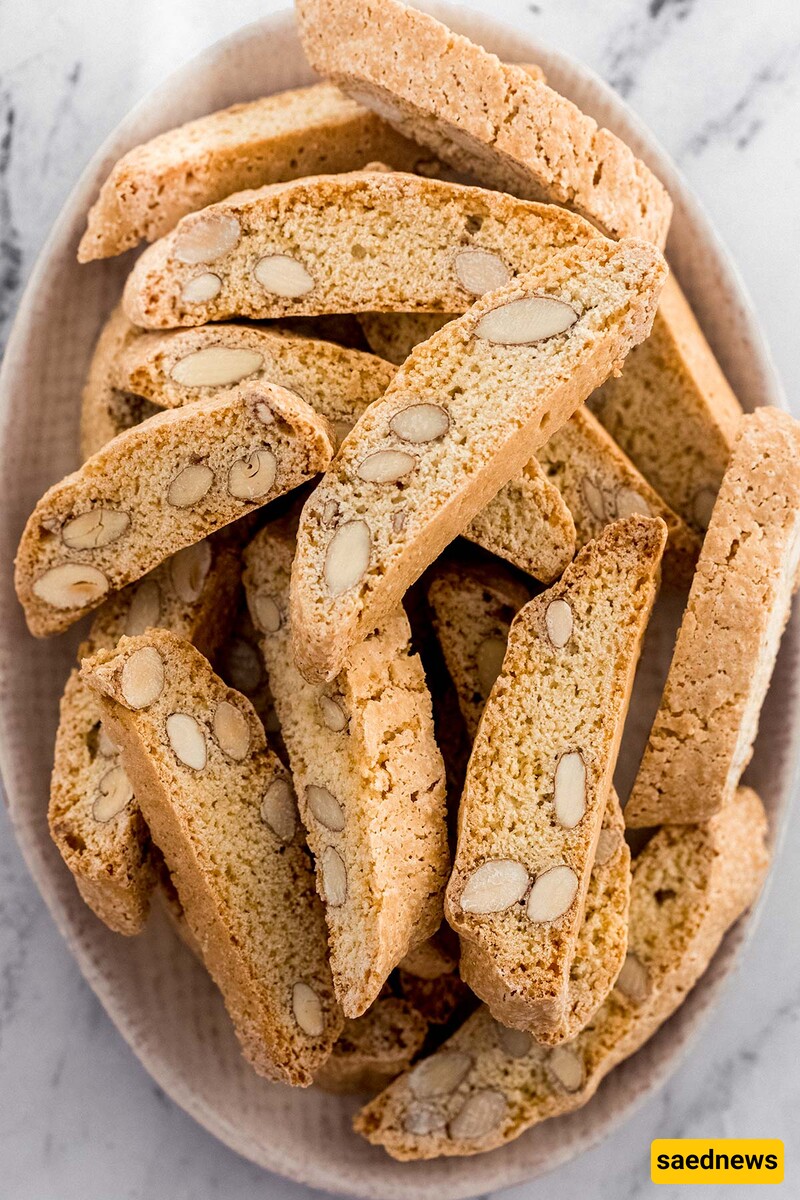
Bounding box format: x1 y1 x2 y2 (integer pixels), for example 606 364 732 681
0 0 800 1200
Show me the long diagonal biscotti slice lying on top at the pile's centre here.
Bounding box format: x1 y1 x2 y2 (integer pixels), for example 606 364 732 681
291 239 666 680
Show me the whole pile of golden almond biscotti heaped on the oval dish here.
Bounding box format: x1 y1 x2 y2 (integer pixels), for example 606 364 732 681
16 0 800 1159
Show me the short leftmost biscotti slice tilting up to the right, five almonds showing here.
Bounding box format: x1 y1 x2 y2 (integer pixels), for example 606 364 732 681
14 383 333 637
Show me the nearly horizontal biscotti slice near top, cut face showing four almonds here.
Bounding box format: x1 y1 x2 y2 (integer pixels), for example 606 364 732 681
124 170 600 329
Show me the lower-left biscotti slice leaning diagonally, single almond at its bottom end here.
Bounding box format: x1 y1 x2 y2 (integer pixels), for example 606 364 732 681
82 630 342 1086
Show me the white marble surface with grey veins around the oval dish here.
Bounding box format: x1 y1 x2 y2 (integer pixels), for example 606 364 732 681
0 0 800 1200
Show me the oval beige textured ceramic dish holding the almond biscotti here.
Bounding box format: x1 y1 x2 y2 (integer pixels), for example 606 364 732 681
0 5 800 1200
